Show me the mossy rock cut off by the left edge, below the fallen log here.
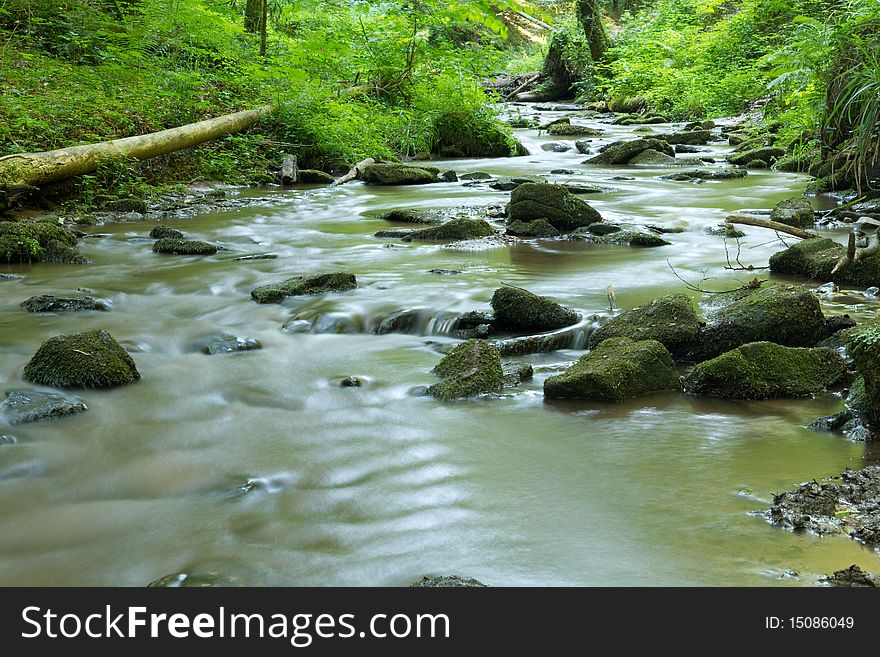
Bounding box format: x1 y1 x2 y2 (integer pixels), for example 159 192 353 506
0 221 87 264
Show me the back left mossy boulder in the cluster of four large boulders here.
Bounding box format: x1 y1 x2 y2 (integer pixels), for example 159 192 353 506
587 294 702 358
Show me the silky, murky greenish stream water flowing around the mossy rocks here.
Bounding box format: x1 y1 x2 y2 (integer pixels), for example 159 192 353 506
0 109 880 586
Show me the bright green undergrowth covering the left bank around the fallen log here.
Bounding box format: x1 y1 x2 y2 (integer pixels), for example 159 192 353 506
0 0 522 204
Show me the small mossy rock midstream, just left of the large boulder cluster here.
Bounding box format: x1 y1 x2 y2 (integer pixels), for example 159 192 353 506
428 339 504 399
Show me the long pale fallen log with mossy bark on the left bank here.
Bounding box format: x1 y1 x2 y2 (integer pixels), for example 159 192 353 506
0 105 272 186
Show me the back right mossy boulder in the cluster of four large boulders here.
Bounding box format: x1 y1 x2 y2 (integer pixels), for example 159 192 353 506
689 285 825 361
